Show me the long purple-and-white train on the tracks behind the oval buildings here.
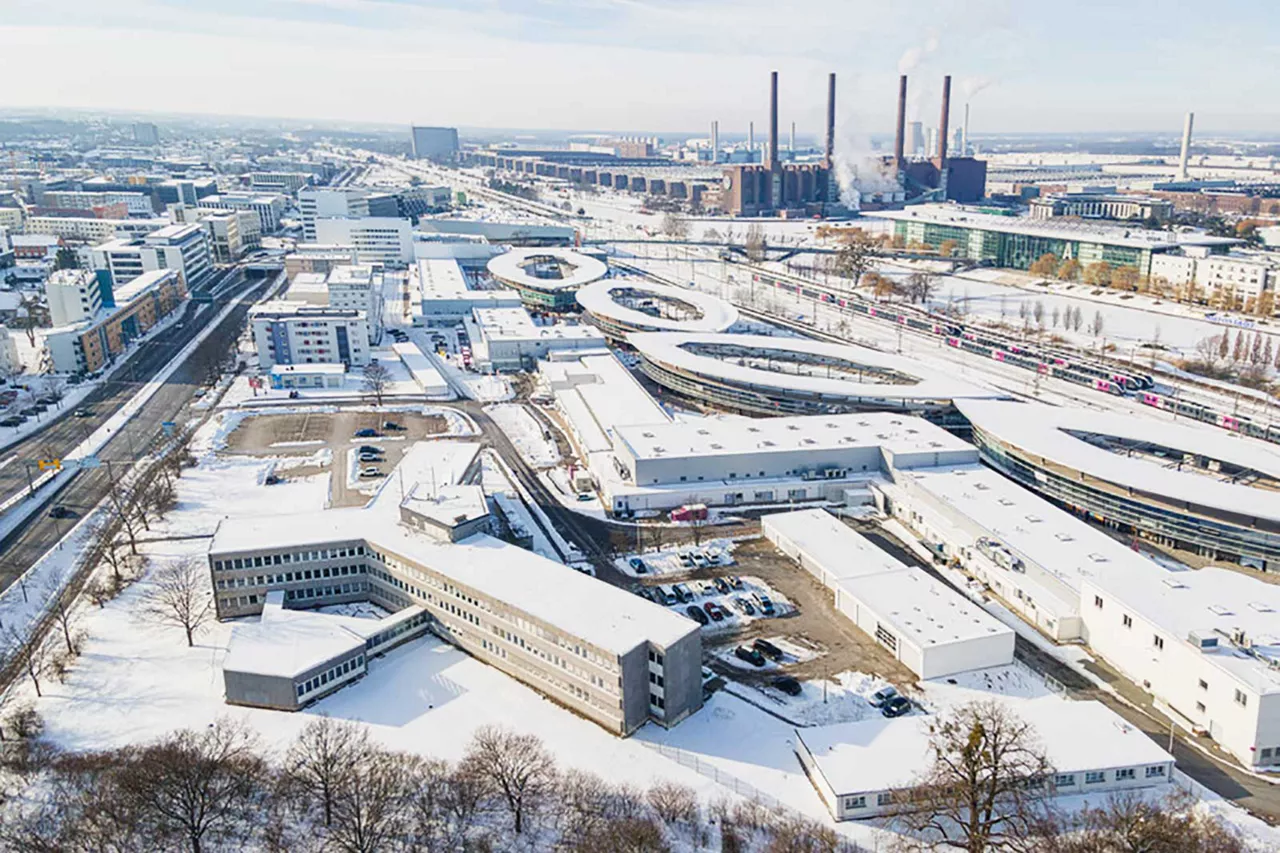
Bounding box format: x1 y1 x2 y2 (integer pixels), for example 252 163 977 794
751 272 1280 444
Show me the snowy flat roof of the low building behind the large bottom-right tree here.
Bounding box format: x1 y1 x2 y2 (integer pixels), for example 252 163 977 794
795 695 1172 797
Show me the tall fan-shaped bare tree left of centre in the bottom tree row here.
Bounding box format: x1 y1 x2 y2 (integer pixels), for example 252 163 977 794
460 726 556 835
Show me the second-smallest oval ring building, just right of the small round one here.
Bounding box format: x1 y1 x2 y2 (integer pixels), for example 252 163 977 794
577 278 737 342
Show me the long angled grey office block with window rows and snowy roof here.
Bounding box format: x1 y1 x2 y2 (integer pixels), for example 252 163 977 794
209 444 703 736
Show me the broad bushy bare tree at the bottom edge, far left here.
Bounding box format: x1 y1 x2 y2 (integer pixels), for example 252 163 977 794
118 720 266 853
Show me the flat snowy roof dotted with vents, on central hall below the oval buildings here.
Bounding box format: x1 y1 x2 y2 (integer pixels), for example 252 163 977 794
617 412 977 460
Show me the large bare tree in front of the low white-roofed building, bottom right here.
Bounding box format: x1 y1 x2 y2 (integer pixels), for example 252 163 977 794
896 702 1052 853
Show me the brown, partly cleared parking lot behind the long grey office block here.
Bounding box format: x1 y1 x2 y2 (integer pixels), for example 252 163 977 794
225 411 448 507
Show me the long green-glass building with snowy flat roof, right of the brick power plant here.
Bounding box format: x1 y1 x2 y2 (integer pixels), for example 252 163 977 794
876 205 1240 275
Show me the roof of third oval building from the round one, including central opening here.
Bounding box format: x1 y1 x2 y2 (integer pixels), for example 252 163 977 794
627 332 1000 405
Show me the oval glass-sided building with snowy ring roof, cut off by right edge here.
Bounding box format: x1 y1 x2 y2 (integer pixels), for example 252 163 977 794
957 400 1280 569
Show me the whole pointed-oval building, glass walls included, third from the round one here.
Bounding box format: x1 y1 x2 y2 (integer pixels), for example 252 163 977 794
627 332 1000 415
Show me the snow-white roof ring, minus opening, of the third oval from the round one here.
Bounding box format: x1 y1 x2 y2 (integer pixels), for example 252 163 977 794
627 332 1004 401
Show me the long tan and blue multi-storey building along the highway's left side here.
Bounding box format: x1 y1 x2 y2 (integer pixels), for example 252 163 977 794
45 269 187 374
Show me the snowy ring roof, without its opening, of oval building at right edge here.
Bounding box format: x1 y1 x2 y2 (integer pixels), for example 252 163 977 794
956 400 1280 521
